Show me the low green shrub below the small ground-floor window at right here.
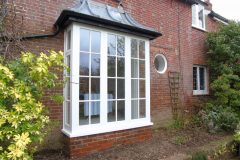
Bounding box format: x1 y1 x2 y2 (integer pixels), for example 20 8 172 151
200 106 239 132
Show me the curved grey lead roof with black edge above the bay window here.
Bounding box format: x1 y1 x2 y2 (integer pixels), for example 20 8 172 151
55 0 162 39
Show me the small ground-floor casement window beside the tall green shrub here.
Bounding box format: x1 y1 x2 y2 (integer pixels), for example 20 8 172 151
193 65 208 95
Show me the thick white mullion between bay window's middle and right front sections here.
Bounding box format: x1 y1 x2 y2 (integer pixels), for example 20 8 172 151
125 37 131 121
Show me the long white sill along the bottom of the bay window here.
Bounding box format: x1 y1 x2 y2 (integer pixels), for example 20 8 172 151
62 119 153 138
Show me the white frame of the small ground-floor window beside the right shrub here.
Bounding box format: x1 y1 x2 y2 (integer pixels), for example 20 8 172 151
193 65 209 95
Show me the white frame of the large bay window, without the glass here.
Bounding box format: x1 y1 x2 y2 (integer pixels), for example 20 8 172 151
62 23 153 137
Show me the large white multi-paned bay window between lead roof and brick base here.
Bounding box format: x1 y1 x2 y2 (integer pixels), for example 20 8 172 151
63 23 152 137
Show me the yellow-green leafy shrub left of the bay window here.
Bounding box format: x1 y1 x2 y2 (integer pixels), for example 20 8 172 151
0 51 64 160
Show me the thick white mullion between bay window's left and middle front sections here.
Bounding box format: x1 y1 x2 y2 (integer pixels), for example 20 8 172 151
100 32 108 124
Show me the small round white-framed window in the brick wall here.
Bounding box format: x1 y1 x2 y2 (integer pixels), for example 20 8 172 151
154 54 167 74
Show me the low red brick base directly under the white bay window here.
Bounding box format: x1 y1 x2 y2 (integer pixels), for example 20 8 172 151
64 127 152 158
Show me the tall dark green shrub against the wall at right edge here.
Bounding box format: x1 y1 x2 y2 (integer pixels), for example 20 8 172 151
206 22 240 130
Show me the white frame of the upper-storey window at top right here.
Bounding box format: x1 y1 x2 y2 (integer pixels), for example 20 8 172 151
192 4 206 31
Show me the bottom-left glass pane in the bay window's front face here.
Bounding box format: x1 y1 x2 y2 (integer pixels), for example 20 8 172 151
79 102 89 125
